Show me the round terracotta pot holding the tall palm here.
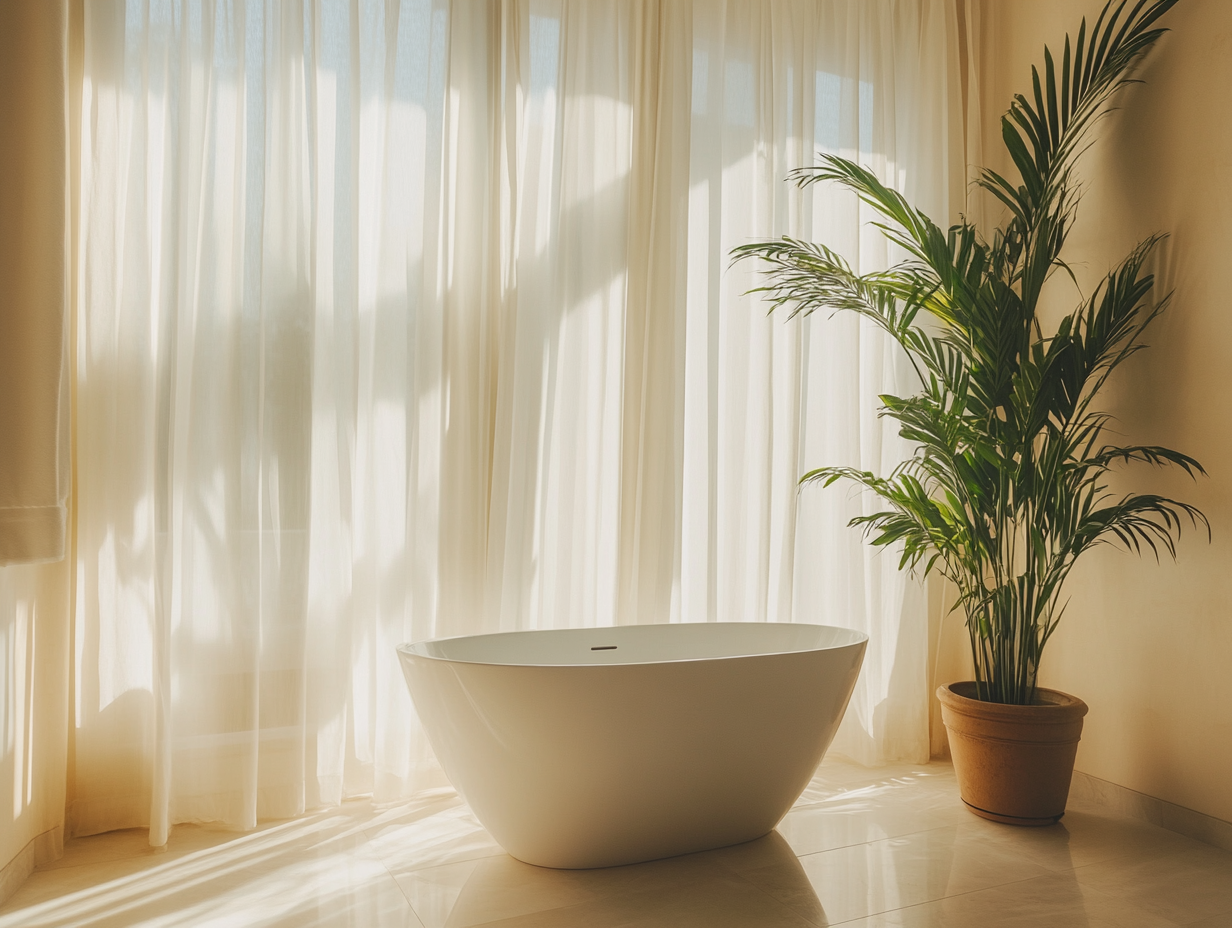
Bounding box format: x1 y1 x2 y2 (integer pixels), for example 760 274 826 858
936 682 1087 824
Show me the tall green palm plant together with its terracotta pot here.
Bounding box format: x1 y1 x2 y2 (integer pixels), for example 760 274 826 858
733 0 1210 824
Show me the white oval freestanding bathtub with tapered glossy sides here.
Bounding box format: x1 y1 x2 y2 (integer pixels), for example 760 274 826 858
398 622 867 869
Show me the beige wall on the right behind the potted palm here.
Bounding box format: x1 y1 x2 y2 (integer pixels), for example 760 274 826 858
965 0 1232 821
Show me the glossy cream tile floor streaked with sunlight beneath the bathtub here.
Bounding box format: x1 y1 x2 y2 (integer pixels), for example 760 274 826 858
0 762 1232 928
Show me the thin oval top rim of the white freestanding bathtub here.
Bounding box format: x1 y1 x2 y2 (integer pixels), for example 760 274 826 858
397 621 869 668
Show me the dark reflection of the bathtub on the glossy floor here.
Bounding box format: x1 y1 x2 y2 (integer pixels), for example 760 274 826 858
437 832 828 928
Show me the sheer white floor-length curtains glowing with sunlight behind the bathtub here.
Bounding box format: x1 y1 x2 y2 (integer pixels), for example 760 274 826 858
70 0 963 844
